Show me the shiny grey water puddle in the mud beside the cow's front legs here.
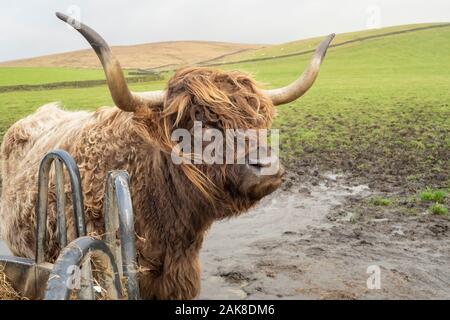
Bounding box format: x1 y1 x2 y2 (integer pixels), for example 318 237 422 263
199 174 370 299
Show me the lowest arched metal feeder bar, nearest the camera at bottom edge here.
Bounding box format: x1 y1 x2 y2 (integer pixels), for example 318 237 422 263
45 237 122 300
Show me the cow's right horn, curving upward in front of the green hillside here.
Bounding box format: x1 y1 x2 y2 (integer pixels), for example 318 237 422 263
263 33 335 105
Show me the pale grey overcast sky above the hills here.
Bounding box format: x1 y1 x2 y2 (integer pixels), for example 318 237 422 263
0 0 450 61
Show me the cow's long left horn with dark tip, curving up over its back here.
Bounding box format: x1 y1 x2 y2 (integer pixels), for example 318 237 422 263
56 12 165 112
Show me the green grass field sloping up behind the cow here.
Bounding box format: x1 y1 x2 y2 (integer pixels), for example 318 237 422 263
0 26 450 189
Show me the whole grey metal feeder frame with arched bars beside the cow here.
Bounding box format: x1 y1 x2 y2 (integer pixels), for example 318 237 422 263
0 150 140 300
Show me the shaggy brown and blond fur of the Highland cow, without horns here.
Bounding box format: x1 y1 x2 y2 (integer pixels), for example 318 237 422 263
0 68 274 299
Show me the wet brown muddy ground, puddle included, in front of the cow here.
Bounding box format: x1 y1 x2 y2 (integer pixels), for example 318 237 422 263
200 172 450 299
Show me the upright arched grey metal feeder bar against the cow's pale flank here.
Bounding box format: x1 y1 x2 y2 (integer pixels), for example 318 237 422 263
36 150 86 264
